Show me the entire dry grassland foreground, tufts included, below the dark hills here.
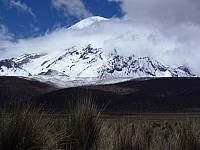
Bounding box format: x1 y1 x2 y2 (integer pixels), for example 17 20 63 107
0 99 200 150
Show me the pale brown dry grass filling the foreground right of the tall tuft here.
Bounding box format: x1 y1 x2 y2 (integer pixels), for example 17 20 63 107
103 119 200 150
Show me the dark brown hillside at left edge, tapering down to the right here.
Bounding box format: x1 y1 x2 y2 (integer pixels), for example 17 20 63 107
0 76 56 105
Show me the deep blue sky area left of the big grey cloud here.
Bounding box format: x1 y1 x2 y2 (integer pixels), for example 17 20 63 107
0 0 123 39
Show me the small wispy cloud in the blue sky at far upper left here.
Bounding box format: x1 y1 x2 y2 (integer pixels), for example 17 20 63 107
9 0 36 17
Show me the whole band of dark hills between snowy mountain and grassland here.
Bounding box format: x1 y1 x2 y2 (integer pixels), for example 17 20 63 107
0 77 200 113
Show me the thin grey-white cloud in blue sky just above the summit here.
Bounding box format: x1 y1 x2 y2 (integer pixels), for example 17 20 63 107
52 0 92 19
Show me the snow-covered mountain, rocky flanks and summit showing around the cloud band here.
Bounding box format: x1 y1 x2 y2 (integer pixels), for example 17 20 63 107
0 17 195 78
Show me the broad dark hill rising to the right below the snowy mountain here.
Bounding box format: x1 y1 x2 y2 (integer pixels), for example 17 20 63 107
35 78 200 112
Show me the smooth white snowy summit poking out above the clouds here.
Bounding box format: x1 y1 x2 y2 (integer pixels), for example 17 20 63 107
68 16 109 29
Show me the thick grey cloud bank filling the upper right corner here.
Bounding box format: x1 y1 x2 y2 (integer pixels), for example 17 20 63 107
108 0 200 41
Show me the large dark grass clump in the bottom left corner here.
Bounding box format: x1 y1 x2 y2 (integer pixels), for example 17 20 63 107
0 103 55 150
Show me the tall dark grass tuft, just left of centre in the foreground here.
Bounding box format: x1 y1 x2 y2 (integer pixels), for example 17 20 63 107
59 98 103 150
